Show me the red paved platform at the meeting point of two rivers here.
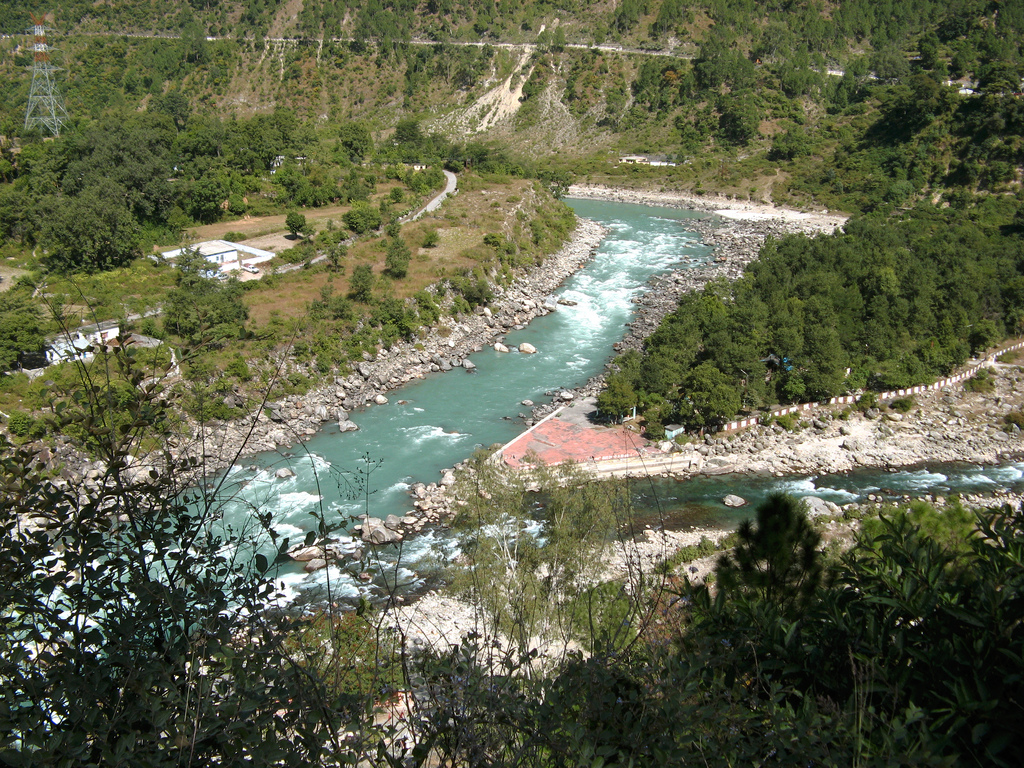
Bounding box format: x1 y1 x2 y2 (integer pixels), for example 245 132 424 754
502 419 660 468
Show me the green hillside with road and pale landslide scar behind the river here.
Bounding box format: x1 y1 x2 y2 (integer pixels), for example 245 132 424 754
0 0 1024 205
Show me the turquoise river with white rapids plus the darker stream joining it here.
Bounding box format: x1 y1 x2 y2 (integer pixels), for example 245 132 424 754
216 200 1024 597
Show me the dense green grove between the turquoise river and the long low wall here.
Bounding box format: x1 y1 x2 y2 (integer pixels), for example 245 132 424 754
633 206 1024 415
